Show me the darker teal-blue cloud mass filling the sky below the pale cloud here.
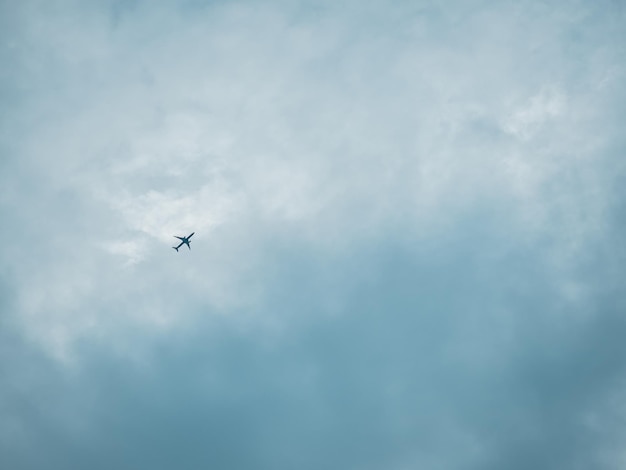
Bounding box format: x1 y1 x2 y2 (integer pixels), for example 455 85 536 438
3 207 626 469
